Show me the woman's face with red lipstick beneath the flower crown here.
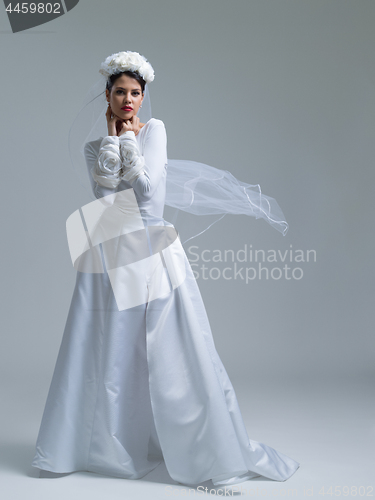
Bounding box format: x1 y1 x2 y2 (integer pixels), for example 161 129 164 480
106 75 143 120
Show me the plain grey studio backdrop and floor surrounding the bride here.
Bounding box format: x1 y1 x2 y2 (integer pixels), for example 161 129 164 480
0 0 375 498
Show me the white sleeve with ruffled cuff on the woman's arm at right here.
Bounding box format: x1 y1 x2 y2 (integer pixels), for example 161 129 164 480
119 119 167 199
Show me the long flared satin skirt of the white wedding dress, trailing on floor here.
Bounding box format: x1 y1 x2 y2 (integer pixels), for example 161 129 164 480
32 216 299 485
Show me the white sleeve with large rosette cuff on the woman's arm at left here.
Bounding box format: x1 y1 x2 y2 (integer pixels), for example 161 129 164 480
84 136 122 198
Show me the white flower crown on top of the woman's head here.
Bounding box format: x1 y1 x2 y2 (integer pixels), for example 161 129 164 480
99 51 155 83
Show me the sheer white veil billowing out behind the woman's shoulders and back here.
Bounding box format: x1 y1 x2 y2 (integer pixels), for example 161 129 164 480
68 76 288 243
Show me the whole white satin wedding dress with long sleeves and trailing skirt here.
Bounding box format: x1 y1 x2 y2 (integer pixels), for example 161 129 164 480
32 118 299 485
